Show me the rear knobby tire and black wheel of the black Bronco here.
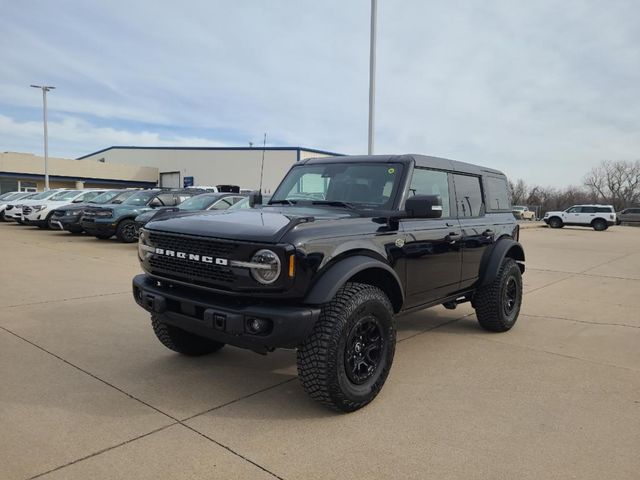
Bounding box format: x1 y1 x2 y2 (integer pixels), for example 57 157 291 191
473 258 522 332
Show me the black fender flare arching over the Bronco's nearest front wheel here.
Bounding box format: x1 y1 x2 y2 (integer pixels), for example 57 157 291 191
303 255 404 311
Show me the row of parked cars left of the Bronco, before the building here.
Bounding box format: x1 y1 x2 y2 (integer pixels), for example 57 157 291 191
0 185 249 243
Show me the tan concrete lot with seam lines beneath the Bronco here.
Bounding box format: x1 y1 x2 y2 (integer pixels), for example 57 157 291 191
0 224 640 480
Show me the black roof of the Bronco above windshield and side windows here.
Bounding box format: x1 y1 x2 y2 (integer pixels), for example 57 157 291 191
299 154 503 175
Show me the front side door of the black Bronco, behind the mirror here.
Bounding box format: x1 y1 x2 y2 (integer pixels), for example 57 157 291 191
401 168 462 308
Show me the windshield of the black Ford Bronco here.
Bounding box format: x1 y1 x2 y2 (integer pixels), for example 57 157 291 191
269 163 402 208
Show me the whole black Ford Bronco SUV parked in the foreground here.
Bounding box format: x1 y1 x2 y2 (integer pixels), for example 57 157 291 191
133 155 524 411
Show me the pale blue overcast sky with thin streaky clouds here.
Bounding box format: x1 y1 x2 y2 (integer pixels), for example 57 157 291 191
0 0 640 186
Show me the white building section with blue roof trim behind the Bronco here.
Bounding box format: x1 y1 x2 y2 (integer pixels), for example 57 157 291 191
78 146 339 194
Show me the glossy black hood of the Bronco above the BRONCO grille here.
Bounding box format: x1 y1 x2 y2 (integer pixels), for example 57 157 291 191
145 206 360 243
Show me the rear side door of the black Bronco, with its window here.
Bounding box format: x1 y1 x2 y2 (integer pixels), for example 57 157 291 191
453 173 494 289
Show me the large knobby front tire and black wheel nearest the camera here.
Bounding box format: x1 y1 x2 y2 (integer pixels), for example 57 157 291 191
297 283 396 412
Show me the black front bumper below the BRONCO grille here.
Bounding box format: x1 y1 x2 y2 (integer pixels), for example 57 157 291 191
133 274 320 352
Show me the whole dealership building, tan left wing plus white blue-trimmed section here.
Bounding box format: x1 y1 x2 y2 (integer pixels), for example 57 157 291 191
0 146 340 194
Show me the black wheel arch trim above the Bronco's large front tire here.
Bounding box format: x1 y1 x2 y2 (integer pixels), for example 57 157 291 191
303 254 404 313
